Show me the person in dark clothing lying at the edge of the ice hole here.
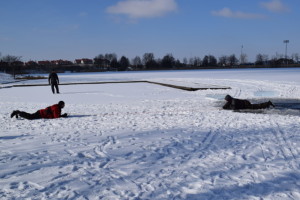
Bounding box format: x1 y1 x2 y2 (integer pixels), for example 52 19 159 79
223 95 275 110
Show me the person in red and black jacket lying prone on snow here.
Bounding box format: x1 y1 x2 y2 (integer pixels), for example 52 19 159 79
10 101 68 120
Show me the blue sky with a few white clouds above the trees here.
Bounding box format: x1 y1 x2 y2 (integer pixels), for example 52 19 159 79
0 0 300 62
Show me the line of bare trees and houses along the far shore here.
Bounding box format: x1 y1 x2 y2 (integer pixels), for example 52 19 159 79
0 53 299 73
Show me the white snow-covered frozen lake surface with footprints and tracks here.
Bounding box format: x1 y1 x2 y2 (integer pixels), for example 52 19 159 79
0 69 300 200
